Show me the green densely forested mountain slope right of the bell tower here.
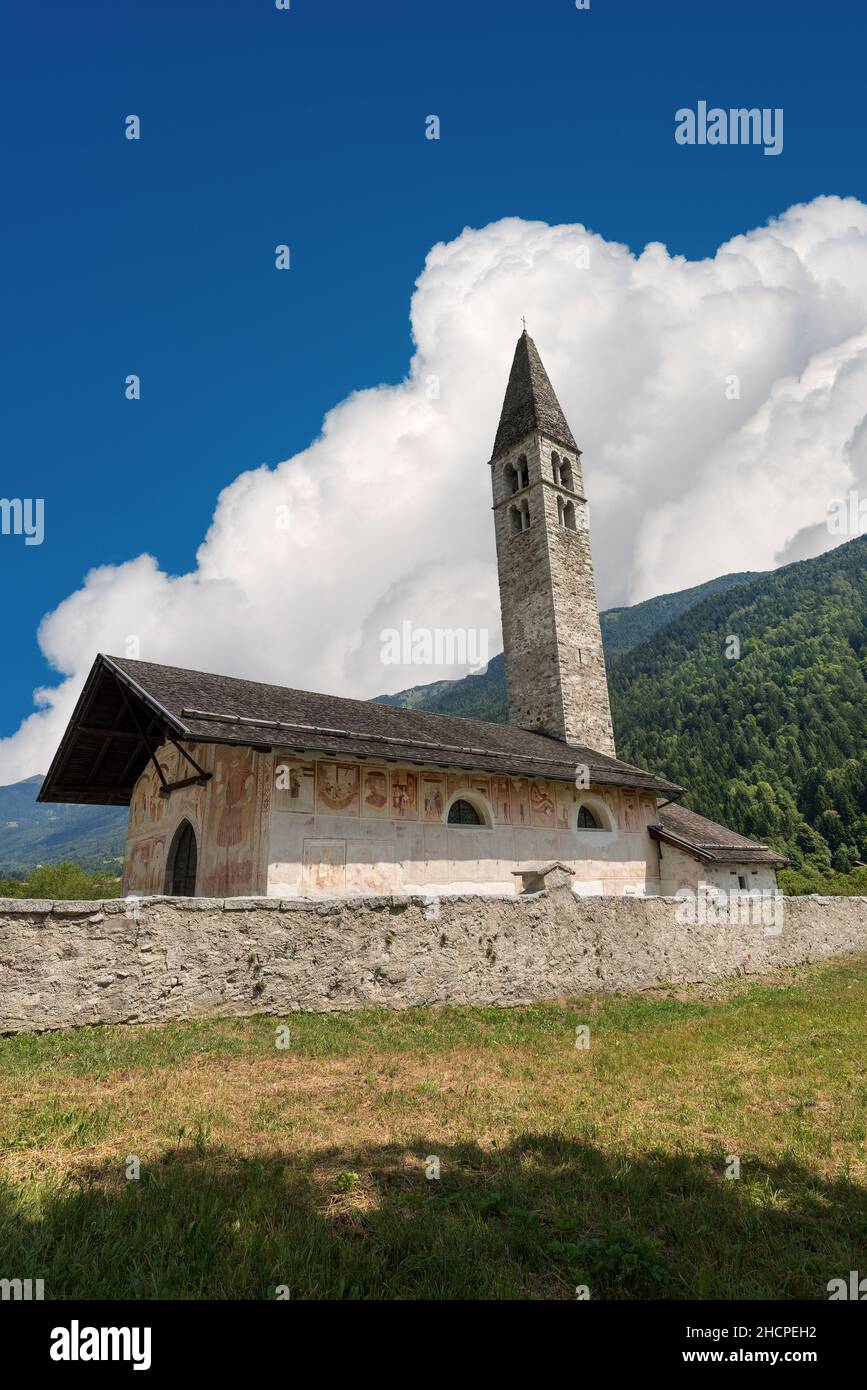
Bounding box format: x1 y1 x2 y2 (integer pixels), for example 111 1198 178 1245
610 537 867 870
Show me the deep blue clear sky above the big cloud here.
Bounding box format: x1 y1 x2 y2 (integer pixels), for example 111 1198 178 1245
0 0 867 770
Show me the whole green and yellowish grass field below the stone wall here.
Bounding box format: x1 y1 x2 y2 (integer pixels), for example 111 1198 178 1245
0 958 867 1298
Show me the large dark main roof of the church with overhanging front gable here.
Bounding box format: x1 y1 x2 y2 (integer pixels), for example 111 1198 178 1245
38 656 681 805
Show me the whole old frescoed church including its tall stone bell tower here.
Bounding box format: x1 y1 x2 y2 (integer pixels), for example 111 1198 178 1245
39 331 784 898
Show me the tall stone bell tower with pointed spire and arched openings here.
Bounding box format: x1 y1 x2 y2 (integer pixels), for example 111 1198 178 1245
490 329 614 756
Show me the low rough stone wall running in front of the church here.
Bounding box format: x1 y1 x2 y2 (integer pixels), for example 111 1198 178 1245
0 887 867 1033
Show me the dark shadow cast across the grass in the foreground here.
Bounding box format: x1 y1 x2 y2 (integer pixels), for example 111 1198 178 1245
0 1134 867 1300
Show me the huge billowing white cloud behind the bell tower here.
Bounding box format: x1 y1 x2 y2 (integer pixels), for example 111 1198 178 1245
0 197 867 783
